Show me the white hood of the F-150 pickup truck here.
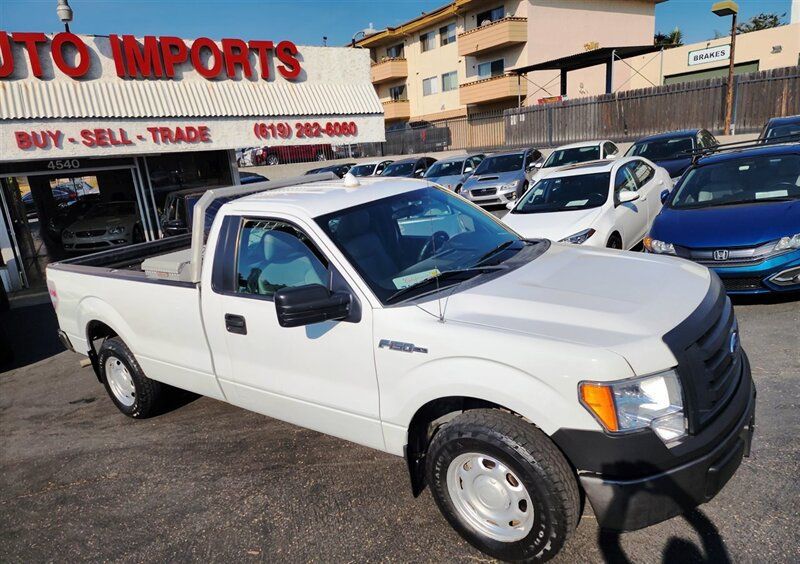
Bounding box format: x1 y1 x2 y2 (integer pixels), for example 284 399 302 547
434 244 712 374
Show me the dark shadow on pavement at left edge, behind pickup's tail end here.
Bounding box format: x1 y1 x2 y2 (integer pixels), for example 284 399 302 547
0 303 64 372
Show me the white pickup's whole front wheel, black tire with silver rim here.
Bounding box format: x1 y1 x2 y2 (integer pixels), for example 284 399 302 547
426 409 580 562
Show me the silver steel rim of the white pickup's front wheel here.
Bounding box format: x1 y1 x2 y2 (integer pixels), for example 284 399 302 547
447 452 534 542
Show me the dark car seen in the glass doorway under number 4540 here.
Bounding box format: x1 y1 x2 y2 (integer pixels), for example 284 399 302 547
61 202 144 251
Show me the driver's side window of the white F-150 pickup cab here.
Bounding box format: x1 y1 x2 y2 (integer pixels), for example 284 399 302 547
236 219 328 297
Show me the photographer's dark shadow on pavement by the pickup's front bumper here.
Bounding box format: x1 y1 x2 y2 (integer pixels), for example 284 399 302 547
597 467 731 564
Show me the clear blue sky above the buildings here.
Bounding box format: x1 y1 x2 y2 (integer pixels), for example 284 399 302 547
0 0 791 45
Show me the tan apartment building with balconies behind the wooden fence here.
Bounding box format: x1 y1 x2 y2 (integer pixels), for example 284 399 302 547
356 0 660 128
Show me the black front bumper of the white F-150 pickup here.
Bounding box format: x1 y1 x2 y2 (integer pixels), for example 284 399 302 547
553 350 756 531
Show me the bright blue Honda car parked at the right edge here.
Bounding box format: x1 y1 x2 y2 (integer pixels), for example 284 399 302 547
645 143 800 294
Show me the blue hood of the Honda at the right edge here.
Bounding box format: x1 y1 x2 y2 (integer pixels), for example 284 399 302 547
650 200 800 248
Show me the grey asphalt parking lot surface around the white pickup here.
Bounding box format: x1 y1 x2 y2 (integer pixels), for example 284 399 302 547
0 296 800 562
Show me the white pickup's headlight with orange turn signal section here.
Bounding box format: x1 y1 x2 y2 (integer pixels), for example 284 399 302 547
579 370 686 443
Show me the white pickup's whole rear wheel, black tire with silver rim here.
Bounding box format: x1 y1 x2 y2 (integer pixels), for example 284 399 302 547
97 337 168 419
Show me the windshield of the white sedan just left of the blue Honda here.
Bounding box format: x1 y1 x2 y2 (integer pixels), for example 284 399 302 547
511 172 611 213
